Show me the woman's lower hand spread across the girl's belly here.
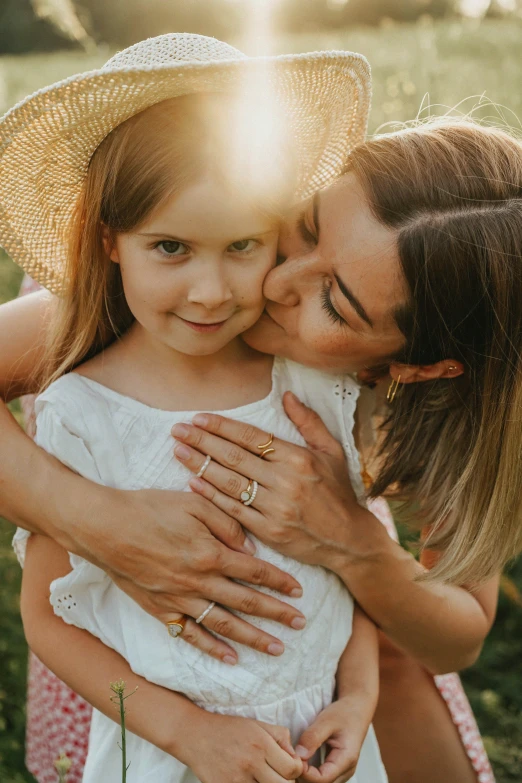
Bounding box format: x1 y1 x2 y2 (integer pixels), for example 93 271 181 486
76 488 305 665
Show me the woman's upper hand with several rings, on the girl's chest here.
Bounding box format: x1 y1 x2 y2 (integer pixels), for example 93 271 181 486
172 393 376 570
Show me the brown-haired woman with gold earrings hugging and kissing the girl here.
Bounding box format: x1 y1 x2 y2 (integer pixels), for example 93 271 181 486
0 118 522 783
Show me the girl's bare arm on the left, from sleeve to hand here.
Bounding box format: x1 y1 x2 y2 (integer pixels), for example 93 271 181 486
21 536 302 783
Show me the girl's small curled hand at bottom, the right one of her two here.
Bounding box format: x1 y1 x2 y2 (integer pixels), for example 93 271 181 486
296 696 371 783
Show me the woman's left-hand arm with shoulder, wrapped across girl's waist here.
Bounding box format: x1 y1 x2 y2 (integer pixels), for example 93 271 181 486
0 292 302 659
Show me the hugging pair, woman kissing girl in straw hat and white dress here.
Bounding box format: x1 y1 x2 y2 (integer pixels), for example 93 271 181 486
0 27 522 783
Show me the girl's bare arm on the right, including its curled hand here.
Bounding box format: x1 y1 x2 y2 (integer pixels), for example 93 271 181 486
296 604 379 783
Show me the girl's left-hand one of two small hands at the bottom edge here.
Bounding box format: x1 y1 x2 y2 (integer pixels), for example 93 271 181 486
176 711 303 783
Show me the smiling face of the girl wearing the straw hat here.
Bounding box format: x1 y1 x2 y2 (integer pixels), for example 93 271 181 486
110 180 279 356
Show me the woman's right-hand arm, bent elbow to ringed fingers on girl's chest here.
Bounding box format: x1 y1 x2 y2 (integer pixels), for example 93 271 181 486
170 394 496 673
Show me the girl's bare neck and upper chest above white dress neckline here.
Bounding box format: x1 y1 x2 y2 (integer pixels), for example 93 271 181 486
77 324 273 411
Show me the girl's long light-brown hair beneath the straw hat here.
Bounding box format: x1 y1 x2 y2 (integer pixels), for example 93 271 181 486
35 93 294 389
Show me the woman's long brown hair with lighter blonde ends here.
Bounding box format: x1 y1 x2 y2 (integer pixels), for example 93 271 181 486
349 121 522 585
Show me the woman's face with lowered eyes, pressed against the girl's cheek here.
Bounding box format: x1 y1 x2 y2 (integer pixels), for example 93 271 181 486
244 174 407 372
